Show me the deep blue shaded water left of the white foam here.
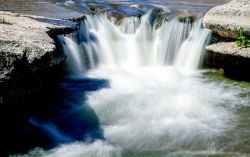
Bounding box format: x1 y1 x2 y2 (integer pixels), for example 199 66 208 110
42 77 108 144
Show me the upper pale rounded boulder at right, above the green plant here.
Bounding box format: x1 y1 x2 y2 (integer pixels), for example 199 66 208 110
203 0 250 38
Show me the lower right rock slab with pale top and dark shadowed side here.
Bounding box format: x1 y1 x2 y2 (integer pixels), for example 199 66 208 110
205 42 250 81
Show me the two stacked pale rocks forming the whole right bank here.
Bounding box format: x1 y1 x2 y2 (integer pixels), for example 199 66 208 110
203 0 250 81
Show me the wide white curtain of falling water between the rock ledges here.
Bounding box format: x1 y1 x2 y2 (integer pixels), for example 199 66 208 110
58 11 210 73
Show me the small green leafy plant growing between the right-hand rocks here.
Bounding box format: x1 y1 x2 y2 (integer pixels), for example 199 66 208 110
235 28 250 48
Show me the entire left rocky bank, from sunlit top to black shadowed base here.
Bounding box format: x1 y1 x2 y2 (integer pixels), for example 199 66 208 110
0 0 84 156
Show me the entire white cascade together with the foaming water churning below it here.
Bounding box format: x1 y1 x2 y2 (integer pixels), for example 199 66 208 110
22 12 250 157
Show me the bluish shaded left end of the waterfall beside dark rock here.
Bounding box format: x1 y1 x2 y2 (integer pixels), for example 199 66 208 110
58 22 99 75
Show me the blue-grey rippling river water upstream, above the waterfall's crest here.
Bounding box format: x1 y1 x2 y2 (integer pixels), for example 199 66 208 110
59 0 229 14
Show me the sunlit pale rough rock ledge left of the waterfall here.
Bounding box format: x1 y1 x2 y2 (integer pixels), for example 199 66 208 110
0 11 81 79
